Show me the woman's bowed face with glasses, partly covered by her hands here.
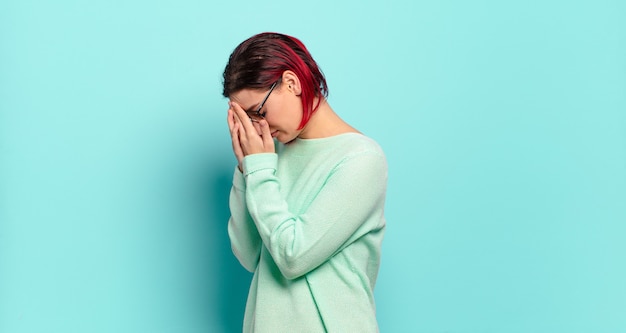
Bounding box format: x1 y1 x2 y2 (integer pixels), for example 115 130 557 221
230 83 302 143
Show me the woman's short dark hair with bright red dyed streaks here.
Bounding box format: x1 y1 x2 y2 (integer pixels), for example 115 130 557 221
223 32 328 129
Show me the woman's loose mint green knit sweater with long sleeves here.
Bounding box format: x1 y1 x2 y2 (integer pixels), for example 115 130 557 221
228 133 387 333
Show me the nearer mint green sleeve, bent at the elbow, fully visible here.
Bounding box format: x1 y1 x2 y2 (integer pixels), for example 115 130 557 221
243 151 387 279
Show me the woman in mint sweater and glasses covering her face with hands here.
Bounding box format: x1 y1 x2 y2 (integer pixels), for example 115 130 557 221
219 33 387 333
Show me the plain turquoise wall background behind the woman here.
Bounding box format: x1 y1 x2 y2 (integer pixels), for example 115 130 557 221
0 0 626 333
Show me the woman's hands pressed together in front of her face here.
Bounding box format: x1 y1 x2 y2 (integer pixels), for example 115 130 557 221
228 102 275 171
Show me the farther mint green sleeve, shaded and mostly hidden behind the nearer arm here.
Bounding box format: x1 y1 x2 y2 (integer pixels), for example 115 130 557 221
228 168 261 272
